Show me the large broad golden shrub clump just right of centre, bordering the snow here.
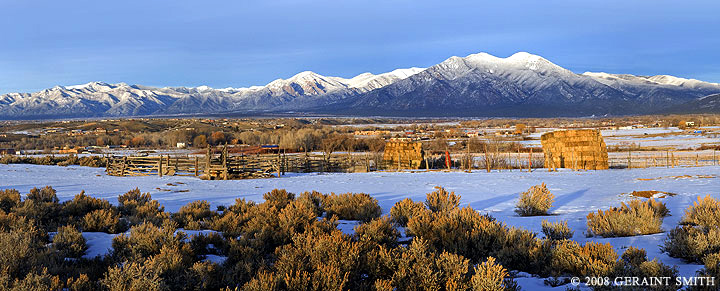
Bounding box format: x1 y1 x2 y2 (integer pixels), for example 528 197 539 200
406 207 507 262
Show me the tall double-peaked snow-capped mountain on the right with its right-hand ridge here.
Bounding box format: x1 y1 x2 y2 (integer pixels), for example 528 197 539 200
333 52 720 116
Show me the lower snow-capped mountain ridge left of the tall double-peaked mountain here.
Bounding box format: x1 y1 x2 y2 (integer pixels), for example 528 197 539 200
0 68 422 118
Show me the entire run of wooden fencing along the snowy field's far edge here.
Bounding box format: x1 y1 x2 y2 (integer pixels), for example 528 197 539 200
106 148 720 179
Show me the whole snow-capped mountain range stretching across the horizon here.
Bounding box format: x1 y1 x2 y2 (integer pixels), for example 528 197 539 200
0 52 720 119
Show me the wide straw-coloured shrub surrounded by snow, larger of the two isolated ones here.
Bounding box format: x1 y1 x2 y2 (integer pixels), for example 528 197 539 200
587 199 667 237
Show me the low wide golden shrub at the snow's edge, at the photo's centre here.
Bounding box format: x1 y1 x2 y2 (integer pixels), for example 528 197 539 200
323 193 382 222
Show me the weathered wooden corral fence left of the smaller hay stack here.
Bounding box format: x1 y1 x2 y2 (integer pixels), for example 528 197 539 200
106 148 375 179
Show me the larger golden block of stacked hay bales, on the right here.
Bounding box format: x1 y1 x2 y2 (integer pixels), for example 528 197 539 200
540 129 608 170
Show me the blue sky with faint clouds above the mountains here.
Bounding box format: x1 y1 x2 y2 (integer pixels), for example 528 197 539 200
0 0 720 93
